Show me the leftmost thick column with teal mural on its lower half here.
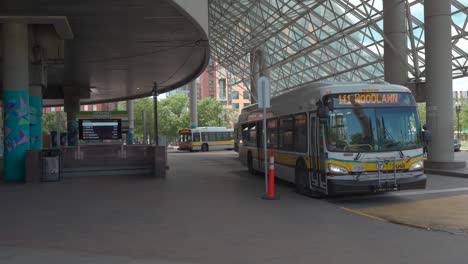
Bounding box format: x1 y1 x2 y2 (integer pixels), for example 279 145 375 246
2 23 29 181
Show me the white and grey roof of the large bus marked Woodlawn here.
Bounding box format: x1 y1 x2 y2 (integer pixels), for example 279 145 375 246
240 82 411 122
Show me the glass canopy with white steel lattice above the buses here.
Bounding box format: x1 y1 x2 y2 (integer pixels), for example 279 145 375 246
209 0 468 94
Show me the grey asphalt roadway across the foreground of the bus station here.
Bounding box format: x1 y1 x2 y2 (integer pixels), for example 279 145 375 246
0 151 468 264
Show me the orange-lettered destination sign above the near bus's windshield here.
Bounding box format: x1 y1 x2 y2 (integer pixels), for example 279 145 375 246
327 93 416 108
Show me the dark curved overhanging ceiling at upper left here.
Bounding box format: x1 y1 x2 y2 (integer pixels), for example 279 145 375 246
0 0 209 105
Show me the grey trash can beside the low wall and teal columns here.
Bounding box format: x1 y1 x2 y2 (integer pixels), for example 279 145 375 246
41 149 62 182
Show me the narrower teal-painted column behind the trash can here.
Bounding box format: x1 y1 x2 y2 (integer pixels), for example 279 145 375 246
29 64 45 149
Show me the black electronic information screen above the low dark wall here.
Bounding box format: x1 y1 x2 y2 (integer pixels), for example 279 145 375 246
79 119 122 140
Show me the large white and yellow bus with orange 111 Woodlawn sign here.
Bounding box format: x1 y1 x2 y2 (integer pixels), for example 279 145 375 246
239 83 426 195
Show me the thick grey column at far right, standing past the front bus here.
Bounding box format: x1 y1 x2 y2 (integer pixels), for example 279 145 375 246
424 0 465 168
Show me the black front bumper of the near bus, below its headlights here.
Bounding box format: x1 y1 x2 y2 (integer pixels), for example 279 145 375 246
328 171 427 195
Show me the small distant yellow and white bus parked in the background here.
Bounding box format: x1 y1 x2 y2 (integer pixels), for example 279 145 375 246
179 127 234 151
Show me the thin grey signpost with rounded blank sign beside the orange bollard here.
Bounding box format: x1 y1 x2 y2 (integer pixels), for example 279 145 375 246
257 76 275 200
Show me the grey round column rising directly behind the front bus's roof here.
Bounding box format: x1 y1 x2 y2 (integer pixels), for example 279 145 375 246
383 0 408 85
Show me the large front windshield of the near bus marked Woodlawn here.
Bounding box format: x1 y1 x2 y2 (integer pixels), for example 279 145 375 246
327 107 421 152
